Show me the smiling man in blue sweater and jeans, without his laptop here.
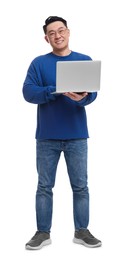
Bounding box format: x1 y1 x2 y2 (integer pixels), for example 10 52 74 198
23 16 101 249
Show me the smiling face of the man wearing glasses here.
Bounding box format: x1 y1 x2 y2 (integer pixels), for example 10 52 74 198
45 21 70 50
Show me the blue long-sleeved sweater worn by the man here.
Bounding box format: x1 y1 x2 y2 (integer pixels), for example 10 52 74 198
23 51 97 140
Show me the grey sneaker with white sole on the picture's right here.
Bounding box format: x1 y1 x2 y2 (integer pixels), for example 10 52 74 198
73 229 102 247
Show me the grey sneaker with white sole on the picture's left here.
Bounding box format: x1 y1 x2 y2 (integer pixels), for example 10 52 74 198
25 231 51 250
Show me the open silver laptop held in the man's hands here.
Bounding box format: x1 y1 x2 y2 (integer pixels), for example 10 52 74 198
53 60 101 94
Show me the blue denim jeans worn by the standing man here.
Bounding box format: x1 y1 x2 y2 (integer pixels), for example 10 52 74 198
36 139 89 232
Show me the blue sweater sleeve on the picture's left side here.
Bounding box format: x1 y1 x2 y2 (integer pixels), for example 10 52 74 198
23 63 56 104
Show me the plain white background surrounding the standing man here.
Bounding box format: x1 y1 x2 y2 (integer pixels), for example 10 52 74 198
0 0 126 260
